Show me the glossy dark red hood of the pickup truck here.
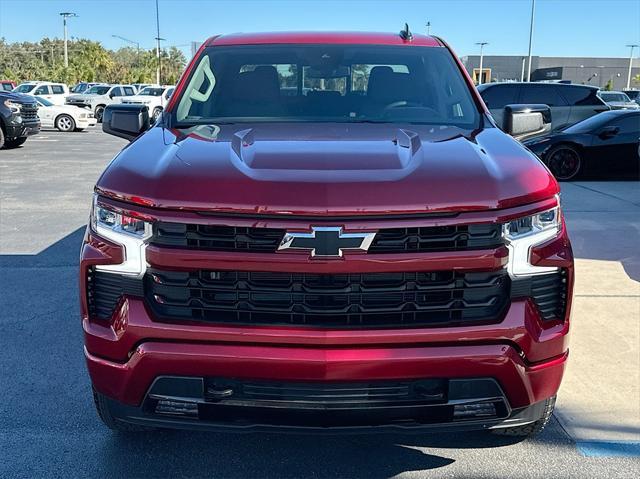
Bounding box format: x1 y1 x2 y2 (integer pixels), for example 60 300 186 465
97 123 558 216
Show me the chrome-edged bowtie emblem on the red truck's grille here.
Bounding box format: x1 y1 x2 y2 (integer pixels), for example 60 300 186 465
278 226 376 258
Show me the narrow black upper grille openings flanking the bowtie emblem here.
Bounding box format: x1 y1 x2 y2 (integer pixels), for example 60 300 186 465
150 222 504 254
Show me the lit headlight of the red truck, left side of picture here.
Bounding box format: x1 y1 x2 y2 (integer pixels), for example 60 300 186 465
91 195 152 276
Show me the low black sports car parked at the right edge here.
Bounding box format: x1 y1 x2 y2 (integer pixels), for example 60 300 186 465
524 110 640 180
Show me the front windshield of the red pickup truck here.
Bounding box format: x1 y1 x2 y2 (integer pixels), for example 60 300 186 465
172 45 479 128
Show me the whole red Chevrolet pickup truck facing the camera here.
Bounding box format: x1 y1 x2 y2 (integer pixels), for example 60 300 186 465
80 29 573 435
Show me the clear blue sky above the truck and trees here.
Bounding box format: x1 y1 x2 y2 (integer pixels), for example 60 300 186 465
0 0 640 57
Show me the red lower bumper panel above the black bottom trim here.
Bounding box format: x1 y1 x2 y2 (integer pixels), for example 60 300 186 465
85 342 566 407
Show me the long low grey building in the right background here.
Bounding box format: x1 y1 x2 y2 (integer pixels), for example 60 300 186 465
462 55 640 90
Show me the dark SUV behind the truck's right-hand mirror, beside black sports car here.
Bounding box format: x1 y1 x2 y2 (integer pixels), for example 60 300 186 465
478 83 610 130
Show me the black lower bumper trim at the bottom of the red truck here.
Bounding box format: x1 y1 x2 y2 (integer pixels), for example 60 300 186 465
96 377 544 433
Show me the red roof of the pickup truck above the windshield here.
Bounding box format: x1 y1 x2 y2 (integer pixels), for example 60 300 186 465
205 32 443 47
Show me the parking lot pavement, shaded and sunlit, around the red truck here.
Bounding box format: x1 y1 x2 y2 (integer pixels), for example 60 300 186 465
0 129 640 478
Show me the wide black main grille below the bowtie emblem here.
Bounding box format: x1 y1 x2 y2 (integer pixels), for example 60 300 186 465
145 270 509 328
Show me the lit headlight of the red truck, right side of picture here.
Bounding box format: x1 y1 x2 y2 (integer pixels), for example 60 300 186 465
502 202 562 276
